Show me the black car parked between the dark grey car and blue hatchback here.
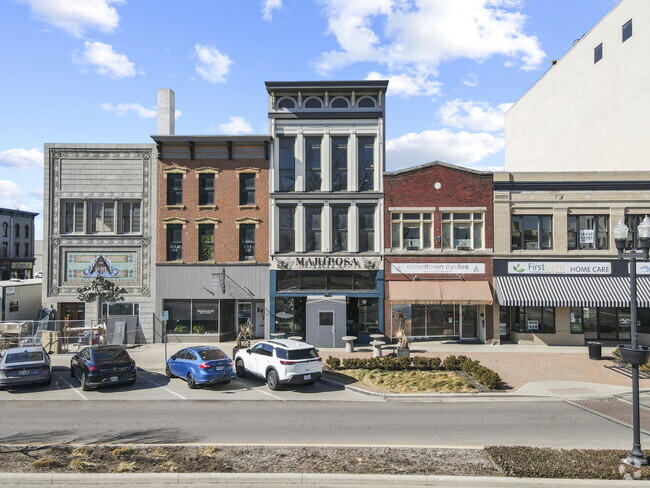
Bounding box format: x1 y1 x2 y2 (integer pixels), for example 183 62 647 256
70 346 136 390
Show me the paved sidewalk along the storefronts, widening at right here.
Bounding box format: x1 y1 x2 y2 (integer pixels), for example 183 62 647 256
52 341 650 399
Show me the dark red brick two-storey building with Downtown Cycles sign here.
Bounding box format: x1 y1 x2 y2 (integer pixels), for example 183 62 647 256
384 161 494 342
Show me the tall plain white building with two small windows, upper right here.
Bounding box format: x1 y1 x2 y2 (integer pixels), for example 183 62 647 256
505 0 650 171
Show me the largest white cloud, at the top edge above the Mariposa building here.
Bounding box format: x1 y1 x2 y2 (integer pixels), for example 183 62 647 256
316 0 546 88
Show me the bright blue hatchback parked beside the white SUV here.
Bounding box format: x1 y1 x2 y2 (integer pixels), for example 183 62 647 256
165 346 235 389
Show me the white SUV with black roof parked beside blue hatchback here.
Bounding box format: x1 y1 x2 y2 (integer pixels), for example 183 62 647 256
235 339 323 390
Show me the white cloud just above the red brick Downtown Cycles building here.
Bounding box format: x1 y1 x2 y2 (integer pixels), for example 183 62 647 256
386 129 504 171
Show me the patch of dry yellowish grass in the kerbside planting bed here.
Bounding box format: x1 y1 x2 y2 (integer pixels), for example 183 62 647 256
338 369 477 393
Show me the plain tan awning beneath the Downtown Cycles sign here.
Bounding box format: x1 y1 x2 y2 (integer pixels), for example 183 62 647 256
388 281 493 305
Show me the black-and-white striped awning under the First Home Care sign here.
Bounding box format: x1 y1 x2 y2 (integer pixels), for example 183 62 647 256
496 276 650 307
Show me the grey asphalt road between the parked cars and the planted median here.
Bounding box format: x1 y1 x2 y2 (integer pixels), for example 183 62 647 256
0 400 650 449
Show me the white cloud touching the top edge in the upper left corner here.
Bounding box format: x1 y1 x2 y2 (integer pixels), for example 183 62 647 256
21 0 124 37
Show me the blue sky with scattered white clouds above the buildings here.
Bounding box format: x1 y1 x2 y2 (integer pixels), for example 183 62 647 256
0 0 624 238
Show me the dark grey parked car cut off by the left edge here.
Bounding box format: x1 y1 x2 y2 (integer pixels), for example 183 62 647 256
0 346 52 387
